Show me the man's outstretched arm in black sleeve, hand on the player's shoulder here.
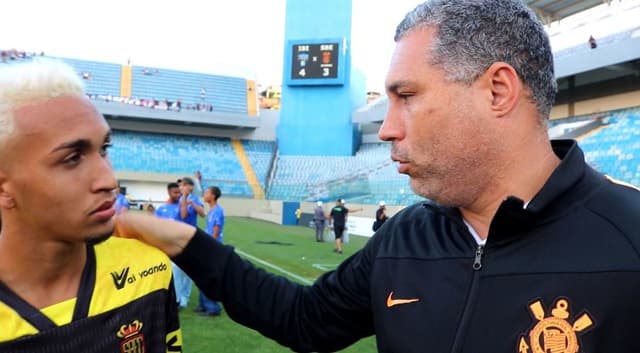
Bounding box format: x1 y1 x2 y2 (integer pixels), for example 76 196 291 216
117 210 374 352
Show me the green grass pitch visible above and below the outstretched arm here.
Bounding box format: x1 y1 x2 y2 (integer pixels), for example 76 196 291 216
180 217 376 353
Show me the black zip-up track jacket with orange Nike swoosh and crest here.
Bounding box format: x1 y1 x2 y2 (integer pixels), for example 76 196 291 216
175 140 640 353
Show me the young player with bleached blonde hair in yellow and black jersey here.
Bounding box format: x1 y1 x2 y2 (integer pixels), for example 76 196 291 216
0 59 182 353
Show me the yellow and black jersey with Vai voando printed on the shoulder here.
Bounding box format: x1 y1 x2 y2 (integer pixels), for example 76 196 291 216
0 237 182 353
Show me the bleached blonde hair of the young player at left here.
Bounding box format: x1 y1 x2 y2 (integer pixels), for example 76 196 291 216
0 58 85 148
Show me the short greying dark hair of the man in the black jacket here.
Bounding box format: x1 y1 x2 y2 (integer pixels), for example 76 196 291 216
394 0 557 121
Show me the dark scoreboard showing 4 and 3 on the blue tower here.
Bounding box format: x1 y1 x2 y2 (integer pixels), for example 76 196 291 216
286 39 346 86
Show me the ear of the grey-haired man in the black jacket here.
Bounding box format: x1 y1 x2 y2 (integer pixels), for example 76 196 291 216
483 62 523 116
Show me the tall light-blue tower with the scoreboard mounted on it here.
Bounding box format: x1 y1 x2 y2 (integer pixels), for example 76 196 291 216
276 0 366 156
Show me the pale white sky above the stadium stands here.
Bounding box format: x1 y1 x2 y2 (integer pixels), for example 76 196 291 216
5 0 640 91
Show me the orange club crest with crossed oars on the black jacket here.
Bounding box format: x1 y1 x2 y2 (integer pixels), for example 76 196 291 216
518 298 593 353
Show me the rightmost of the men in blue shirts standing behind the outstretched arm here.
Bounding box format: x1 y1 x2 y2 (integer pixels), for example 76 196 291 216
197 186 224 316
